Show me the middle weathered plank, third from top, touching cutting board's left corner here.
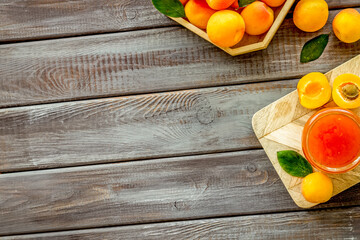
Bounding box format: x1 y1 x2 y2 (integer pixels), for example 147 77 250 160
0 80 296 172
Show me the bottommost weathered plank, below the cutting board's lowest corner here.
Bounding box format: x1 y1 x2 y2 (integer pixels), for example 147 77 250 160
2 207 360 240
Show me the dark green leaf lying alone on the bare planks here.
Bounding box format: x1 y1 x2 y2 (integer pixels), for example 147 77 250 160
300 34 329 63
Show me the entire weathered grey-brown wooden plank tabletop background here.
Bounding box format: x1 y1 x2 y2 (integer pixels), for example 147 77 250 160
0 0 360 239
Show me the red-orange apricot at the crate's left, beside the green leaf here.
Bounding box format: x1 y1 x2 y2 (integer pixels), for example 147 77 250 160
185 0 216 29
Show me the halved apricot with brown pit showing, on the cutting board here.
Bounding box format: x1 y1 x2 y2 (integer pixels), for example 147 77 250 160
332 73 360 108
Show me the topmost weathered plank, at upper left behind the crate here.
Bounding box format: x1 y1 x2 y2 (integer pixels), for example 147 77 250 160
0 0 360 42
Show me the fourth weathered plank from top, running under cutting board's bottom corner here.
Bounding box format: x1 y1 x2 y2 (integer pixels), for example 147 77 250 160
0 150 360 235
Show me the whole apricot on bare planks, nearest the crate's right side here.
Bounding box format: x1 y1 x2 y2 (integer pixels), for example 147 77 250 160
293 0 329 32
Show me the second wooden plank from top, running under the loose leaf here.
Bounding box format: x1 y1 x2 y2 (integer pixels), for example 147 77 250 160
0 9 360 107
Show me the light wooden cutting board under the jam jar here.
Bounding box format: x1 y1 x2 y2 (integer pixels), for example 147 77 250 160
252 55 360 208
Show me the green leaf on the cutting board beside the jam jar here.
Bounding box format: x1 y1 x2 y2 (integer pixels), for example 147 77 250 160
277 150 313 177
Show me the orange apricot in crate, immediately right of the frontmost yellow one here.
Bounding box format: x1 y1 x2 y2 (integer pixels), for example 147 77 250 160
241 1 274 35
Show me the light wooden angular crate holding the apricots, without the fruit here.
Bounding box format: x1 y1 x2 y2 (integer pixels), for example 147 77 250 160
170 0 295 56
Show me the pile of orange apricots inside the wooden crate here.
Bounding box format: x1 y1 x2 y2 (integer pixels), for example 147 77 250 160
181 0 285 47
